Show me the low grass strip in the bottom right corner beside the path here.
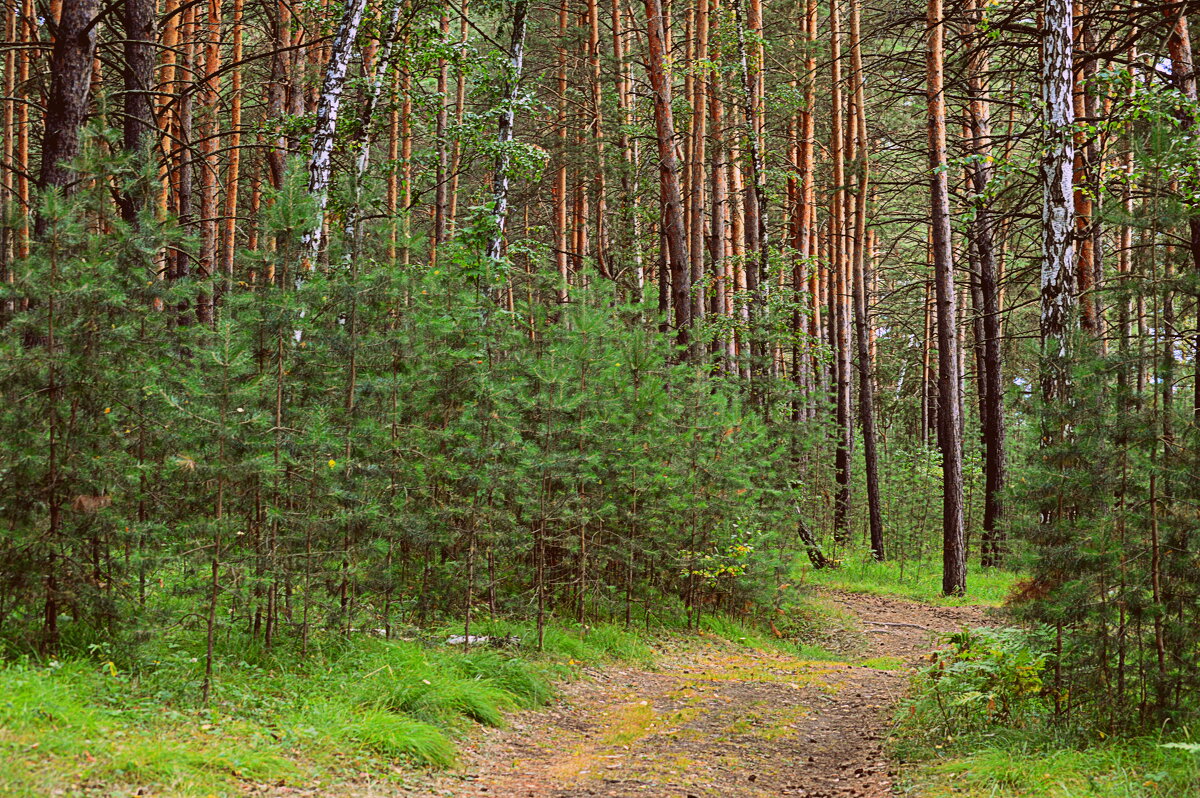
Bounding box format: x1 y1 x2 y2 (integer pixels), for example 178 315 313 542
906 738 1200 798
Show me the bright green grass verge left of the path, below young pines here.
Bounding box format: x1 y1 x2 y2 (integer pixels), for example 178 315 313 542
0 625 652 797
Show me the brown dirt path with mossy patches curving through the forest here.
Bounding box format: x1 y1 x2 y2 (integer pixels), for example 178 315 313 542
410 594 983 798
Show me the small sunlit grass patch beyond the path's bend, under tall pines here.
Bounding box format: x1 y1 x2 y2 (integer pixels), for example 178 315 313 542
796 552 1021 607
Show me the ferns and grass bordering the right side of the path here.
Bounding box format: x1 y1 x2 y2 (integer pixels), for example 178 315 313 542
893 628 1200 798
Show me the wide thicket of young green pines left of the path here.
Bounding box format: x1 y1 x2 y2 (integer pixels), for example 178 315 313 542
0 149 804 676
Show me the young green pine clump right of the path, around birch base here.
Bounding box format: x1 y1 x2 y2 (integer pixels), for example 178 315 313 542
1015 333 1200 734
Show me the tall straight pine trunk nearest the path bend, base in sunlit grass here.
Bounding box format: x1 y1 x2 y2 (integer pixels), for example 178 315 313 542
925 0 967 595
